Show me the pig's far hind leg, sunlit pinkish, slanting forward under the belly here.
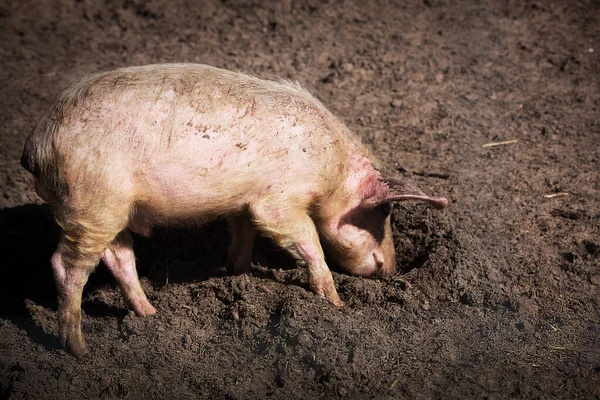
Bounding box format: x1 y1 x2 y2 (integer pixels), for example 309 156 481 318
102 229 156 316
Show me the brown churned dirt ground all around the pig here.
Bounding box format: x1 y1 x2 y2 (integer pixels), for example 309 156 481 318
0 0 600 399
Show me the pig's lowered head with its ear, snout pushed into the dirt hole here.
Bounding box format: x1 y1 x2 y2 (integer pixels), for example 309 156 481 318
322 177 448 276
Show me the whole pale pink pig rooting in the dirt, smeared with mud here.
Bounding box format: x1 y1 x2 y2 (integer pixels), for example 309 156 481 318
21 64 447 357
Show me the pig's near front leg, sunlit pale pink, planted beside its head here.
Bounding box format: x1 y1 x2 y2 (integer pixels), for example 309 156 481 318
251 206 344 307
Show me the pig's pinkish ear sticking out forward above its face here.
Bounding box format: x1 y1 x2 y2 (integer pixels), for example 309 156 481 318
363 178 448 210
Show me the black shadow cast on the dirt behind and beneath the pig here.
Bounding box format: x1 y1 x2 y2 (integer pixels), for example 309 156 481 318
0 204 295 349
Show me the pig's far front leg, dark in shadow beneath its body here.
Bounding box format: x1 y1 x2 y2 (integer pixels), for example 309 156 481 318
227 214 256 275
